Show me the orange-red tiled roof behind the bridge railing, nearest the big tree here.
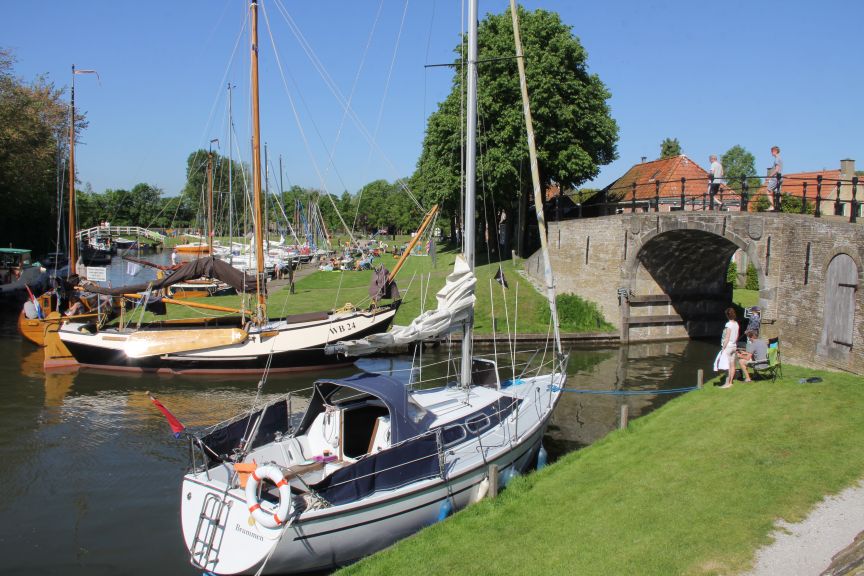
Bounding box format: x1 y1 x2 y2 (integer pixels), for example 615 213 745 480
604 154 738 200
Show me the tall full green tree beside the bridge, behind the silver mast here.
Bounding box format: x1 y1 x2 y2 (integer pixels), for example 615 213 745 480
411 8 618 255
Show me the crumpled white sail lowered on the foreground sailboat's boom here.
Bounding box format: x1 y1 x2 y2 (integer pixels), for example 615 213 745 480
330 254 477 356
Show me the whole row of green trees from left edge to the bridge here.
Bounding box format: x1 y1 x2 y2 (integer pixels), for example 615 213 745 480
0 8 618 253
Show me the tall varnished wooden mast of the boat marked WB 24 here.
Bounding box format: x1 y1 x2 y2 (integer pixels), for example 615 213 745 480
249 0 267 322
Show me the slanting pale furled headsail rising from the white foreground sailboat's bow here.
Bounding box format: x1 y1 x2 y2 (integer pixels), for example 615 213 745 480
510 0 563 354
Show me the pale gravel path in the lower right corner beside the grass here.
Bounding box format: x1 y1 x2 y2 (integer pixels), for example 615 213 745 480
745 480 864 576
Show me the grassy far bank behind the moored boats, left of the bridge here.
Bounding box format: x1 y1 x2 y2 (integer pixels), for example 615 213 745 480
135 244 608 334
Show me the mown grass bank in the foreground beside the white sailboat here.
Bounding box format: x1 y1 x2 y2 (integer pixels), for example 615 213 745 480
340 366 864 576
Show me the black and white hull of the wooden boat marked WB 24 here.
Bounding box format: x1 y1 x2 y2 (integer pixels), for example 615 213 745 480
60 304 398 374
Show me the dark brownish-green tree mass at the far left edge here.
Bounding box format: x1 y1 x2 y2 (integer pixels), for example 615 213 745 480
0 48 75 252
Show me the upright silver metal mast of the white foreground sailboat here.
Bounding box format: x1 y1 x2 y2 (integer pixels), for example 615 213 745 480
461 0 477 386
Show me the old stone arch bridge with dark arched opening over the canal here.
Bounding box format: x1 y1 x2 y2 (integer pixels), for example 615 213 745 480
525 212 864 374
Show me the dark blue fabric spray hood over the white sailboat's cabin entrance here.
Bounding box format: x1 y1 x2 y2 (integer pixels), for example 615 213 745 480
296 373 434 444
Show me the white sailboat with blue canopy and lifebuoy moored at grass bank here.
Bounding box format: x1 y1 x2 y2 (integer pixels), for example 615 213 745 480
181 0 567 574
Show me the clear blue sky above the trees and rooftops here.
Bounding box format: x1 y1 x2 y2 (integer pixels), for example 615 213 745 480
0 0 864 196
